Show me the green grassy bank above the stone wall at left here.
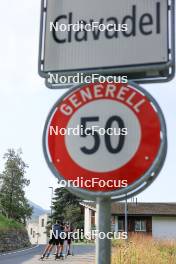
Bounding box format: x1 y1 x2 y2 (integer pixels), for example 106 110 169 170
0 214 24 231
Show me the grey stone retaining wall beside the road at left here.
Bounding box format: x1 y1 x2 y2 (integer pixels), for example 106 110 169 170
0 229 30 253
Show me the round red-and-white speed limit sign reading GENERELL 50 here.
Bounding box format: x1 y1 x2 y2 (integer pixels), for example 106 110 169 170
43 83 167 200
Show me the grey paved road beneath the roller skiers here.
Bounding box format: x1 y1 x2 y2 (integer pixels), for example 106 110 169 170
0 245 95 264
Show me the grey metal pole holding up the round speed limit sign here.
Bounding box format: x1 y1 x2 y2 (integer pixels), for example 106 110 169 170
96 198 111 264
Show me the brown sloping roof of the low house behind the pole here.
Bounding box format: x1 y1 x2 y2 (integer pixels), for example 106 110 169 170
81 202 176 216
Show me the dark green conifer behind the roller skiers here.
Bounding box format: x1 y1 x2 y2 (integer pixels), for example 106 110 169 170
52 187 84 229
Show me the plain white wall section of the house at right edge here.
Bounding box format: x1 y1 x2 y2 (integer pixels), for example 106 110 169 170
152 216 176 239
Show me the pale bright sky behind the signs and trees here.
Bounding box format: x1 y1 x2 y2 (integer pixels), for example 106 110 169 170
0 0 176 209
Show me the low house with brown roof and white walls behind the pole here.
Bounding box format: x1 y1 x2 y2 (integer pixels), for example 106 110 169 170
81 202 176 240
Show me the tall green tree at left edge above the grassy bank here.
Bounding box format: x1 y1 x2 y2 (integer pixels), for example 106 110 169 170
0 149 32 224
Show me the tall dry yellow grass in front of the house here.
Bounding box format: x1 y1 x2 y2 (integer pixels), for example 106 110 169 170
112 235 176 264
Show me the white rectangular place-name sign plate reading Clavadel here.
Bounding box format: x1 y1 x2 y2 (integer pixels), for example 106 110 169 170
40 0 173 85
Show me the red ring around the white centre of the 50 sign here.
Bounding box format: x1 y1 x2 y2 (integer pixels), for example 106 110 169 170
48 83 160 192
